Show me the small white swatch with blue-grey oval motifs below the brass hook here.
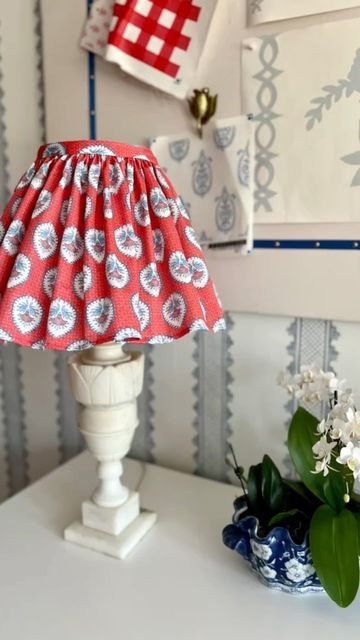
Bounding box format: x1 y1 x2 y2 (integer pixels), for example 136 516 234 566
151 116 254 253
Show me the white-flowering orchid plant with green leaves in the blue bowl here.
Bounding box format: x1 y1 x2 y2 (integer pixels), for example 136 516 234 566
234 365 360 607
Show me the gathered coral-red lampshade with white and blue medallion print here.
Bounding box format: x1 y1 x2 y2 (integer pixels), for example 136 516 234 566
0 140 224 351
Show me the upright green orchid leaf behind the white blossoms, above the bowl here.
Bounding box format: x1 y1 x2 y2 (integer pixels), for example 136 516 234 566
288 407 326 502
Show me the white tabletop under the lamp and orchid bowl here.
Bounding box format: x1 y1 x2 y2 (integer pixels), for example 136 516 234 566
0 454 360 640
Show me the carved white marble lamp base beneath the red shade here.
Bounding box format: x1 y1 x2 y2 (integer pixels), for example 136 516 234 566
64 344 156 559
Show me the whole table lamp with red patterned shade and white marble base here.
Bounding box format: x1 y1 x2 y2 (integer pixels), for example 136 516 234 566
0 140 224 558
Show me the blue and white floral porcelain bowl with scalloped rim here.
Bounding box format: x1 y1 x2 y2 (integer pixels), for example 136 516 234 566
223 499 324 594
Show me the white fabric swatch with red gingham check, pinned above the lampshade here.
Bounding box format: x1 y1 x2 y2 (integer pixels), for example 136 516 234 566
105 0 217 98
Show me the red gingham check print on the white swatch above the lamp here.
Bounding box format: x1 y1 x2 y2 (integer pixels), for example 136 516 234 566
108 0 201 78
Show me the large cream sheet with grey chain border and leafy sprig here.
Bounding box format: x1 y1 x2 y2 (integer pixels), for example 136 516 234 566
242 19 360 223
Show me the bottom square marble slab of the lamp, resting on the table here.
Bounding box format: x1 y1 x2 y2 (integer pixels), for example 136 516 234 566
64 511 156 560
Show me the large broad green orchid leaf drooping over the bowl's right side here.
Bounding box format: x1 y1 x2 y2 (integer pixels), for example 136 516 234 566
310 504 359 607
